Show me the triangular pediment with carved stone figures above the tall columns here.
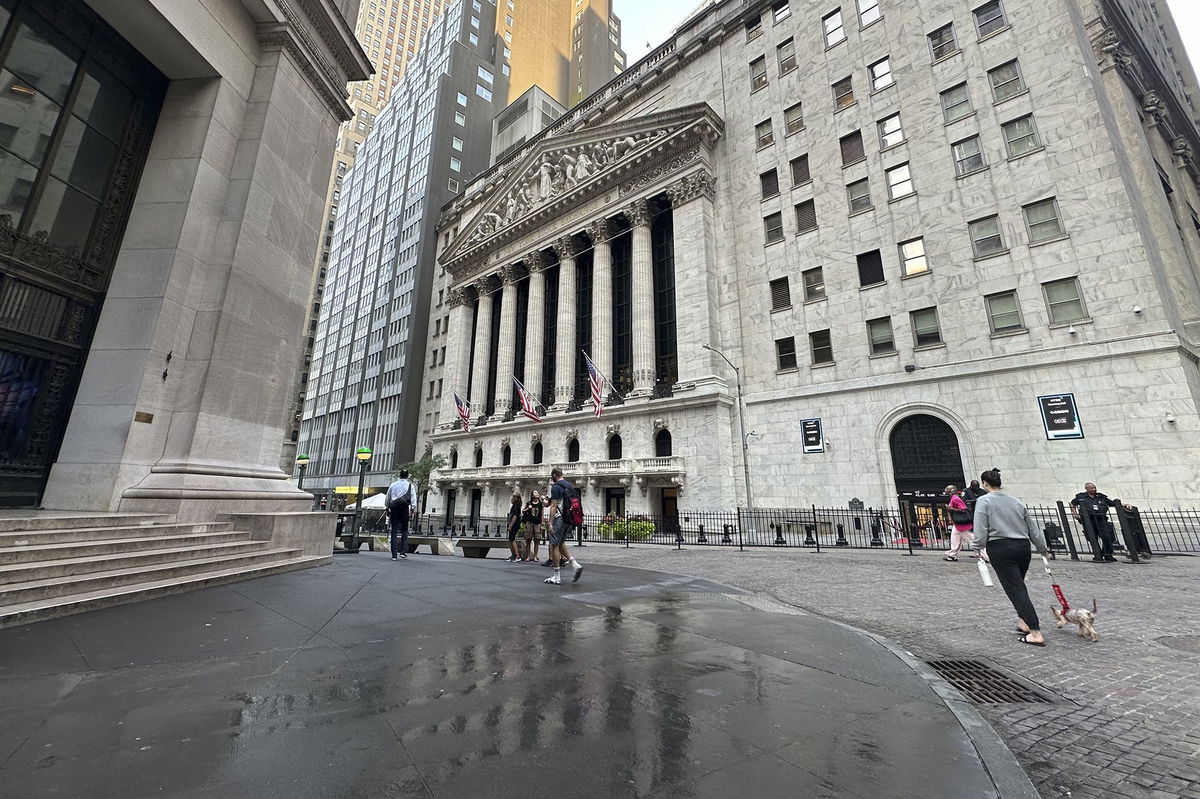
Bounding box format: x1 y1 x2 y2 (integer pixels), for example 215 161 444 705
439 103 724 264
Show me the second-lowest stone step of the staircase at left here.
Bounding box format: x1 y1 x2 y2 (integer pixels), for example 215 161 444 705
0 548 304 604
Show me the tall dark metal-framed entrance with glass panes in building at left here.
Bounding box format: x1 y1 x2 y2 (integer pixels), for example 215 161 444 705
0 0 167 507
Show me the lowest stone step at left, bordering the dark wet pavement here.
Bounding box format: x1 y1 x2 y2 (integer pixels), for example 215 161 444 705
0 549 331 629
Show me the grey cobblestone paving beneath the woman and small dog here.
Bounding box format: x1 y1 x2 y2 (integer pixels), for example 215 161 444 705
577 545 1200 799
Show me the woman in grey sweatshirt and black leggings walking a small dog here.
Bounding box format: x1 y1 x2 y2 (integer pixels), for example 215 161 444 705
973 469 1048 647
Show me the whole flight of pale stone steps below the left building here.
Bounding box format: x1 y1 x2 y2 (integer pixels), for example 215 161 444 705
0 513 332 627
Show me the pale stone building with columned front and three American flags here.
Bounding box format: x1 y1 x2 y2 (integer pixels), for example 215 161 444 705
410 2 1200 522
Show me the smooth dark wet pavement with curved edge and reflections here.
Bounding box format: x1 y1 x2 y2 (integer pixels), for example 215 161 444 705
0 552 1037 799
